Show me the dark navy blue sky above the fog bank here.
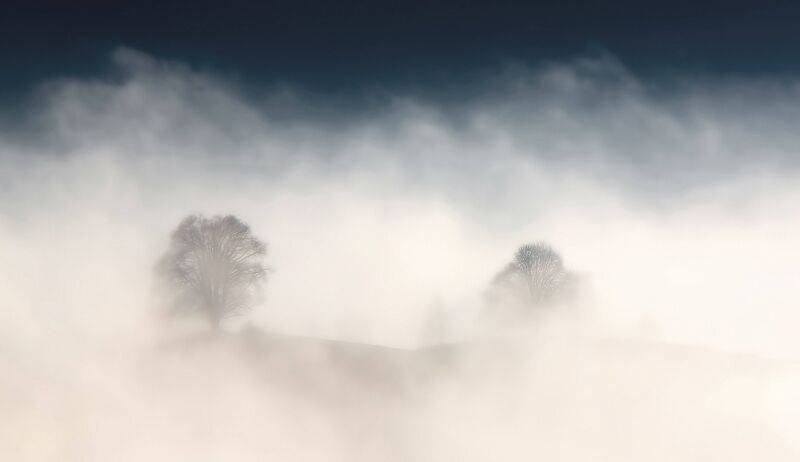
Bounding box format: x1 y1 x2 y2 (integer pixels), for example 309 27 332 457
0 0 800 92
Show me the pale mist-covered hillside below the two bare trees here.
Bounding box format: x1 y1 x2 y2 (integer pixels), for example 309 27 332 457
0 331 800 462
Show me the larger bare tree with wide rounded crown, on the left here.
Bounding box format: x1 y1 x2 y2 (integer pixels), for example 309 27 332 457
156 215 267 330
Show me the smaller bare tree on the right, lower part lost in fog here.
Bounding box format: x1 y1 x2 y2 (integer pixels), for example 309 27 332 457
488 242 577 307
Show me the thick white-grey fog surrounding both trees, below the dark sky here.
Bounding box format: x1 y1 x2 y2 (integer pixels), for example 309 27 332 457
0 49 800 461
